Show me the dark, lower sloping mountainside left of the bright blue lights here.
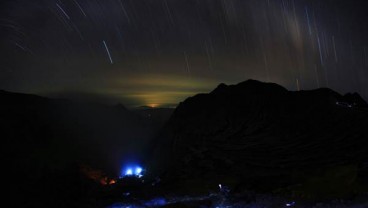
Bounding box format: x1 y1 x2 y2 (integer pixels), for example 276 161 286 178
0 91 173 207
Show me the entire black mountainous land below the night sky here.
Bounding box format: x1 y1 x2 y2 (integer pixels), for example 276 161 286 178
0 80 368 207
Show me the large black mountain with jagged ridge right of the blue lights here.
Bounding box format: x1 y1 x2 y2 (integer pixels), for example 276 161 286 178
153 80 368 200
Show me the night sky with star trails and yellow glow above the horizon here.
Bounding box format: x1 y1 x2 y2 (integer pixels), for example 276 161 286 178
0 0 368 107
